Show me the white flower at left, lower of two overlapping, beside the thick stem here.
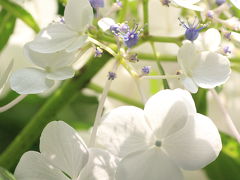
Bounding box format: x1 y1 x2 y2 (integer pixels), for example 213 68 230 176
10 44 76 94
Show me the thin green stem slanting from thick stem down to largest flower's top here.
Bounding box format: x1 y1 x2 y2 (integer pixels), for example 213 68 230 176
87 83 144 108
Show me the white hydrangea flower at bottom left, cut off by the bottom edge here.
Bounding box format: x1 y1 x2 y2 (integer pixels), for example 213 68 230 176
14 121 118 180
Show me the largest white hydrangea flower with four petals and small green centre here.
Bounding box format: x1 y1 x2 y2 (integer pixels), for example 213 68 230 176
97 89 222 180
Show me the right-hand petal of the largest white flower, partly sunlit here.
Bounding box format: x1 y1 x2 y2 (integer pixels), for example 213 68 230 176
162 114 222 170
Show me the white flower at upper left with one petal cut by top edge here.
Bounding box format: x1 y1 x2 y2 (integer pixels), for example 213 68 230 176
29 0 93 53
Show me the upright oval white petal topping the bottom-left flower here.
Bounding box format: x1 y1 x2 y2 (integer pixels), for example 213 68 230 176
40 121 88 179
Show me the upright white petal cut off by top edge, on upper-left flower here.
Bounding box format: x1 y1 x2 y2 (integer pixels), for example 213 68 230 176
64 0 93 32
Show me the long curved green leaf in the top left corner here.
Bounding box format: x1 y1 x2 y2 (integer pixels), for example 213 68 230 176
0 0 40 32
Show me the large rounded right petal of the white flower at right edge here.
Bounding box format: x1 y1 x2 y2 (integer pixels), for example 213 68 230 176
192 52 231 88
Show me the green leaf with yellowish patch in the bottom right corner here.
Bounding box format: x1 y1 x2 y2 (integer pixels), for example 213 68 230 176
204 133 240 180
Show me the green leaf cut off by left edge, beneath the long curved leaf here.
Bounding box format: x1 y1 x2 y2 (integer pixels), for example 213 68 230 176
0 9 16 52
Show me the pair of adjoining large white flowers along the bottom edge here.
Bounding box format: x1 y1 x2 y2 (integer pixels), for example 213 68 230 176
15 89 222 180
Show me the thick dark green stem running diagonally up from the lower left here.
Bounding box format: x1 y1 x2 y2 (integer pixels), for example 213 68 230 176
0 54 111 169
